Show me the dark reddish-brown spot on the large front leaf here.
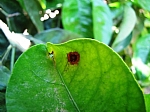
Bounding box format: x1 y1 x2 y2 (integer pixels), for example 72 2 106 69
67 52 80 65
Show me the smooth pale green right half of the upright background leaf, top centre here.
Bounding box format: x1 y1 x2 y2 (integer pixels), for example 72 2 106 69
92 0 112 44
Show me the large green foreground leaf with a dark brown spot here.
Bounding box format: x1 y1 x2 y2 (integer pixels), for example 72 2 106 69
6 39 145 112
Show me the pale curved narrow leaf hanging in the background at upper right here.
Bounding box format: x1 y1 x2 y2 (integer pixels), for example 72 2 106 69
112 5 136 52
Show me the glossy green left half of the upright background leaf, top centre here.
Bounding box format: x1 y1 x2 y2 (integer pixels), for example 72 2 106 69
62 0 93 38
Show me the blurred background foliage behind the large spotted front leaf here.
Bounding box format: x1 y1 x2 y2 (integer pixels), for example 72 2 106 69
0 0 150 111
